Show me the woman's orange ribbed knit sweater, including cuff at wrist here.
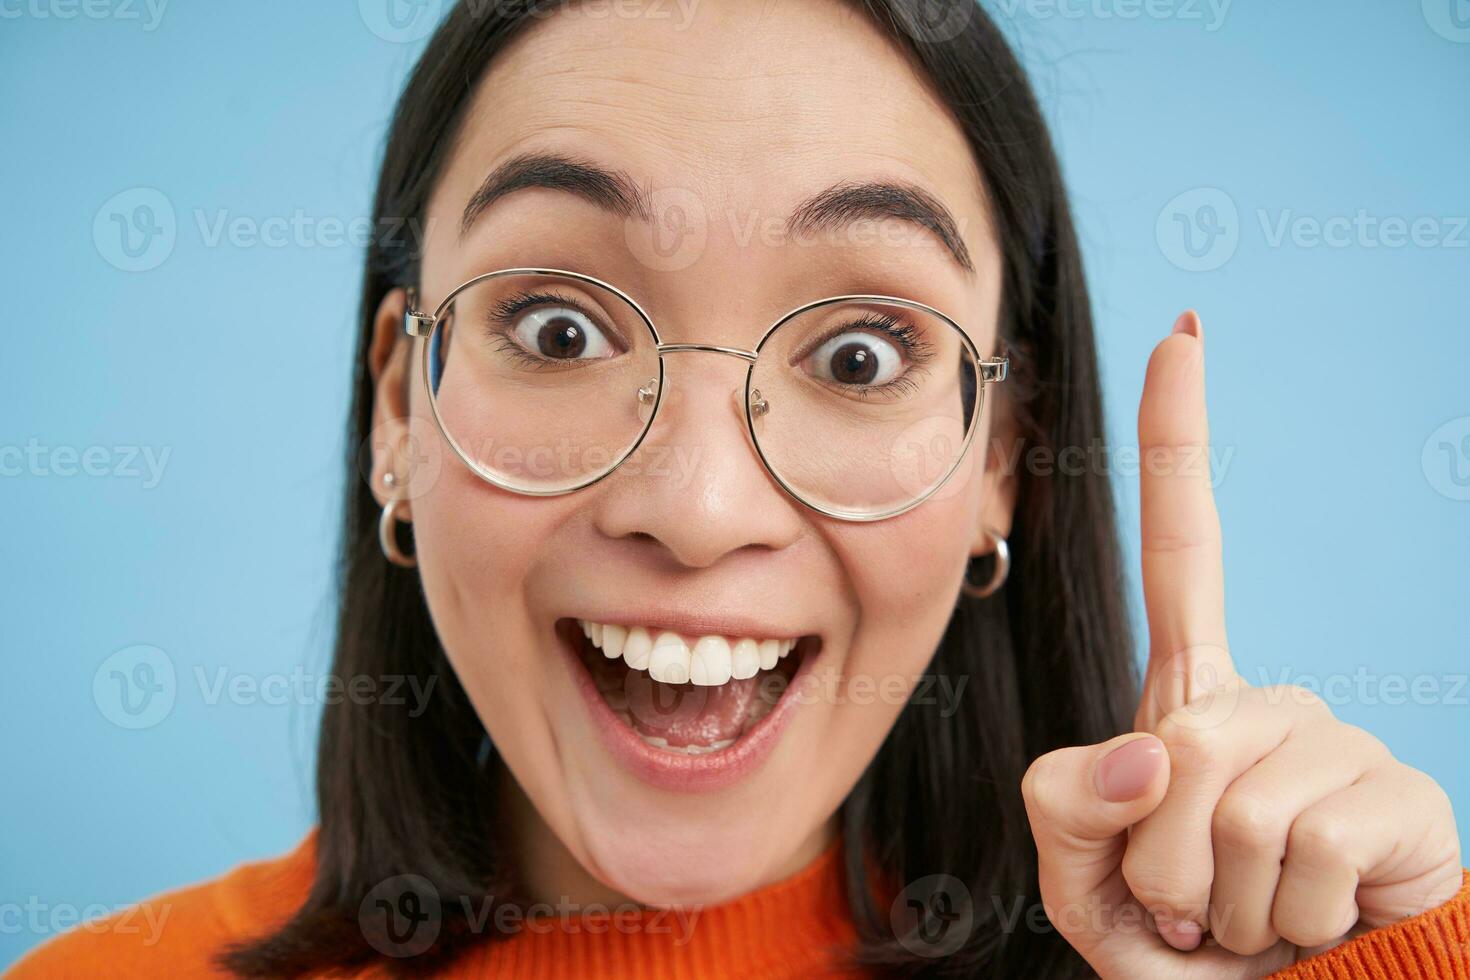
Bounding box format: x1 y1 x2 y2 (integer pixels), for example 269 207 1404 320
9 833 1470 980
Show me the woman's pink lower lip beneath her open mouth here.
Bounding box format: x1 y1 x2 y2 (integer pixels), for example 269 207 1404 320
557 635 822 793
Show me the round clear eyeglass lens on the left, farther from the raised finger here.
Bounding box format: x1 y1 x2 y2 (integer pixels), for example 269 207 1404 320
425 270 662 494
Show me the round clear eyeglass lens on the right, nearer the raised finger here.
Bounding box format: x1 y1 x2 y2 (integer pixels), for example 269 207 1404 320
747 298 982 520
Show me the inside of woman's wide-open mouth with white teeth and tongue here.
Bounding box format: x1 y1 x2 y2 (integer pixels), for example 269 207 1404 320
556 619 822 757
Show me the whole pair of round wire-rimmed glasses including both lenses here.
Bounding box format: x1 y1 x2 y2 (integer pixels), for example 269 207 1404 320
404 269 1008 522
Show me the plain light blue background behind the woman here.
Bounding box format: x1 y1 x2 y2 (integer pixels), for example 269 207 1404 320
0 0 1470 965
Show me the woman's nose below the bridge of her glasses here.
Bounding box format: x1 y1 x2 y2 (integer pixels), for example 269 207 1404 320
595 351 804 569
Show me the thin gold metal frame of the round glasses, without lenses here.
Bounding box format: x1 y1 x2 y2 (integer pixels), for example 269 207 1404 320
403 267 1010 523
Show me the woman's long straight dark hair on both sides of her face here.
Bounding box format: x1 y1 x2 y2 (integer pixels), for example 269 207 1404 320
221 0 1136 977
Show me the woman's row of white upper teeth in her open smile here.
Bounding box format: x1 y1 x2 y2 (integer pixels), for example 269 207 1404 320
578 620 797 688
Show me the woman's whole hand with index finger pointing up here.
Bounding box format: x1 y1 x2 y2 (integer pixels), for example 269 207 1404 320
1022 311 1461 979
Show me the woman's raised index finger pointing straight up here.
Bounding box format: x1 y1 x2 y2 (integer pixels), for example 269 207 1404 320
1138 310 1235 729
